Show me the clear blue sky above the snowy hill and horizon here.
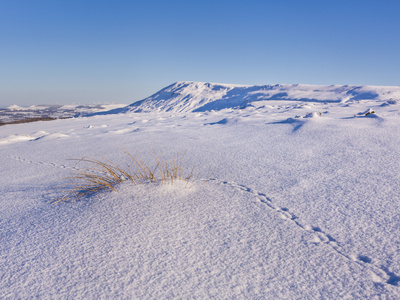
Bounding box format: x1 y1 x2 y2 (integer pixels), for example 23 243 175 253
0 0 400 106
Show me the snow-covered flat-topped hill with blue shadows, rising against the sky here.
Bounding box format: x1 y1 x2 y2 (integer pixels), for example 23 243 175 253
97 81 400 114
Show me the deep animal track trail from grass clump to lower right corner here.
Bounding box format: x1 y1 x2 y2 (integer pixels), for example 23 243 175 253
209 178 400 286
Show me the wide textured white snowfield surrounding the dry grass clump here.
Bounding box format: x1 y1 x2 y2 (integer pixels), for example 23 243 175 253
0 83 400 299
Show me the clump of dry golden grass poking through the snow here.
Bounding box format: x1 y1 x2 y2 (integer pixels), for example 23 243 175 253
52 150 194 203
